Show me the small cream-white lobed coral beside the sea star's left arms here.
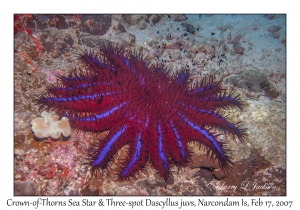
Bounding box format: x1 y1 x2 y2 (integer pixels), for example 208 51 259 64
30 111 71 139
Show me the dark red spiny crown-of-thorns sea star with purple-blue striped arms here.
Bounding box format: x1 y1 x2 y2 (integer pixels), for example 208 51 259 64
37 45 246 181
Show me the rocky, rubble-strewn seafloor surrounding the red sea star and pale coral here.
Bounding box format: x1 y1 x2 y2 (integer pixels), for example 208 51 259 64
14 14 286 196
